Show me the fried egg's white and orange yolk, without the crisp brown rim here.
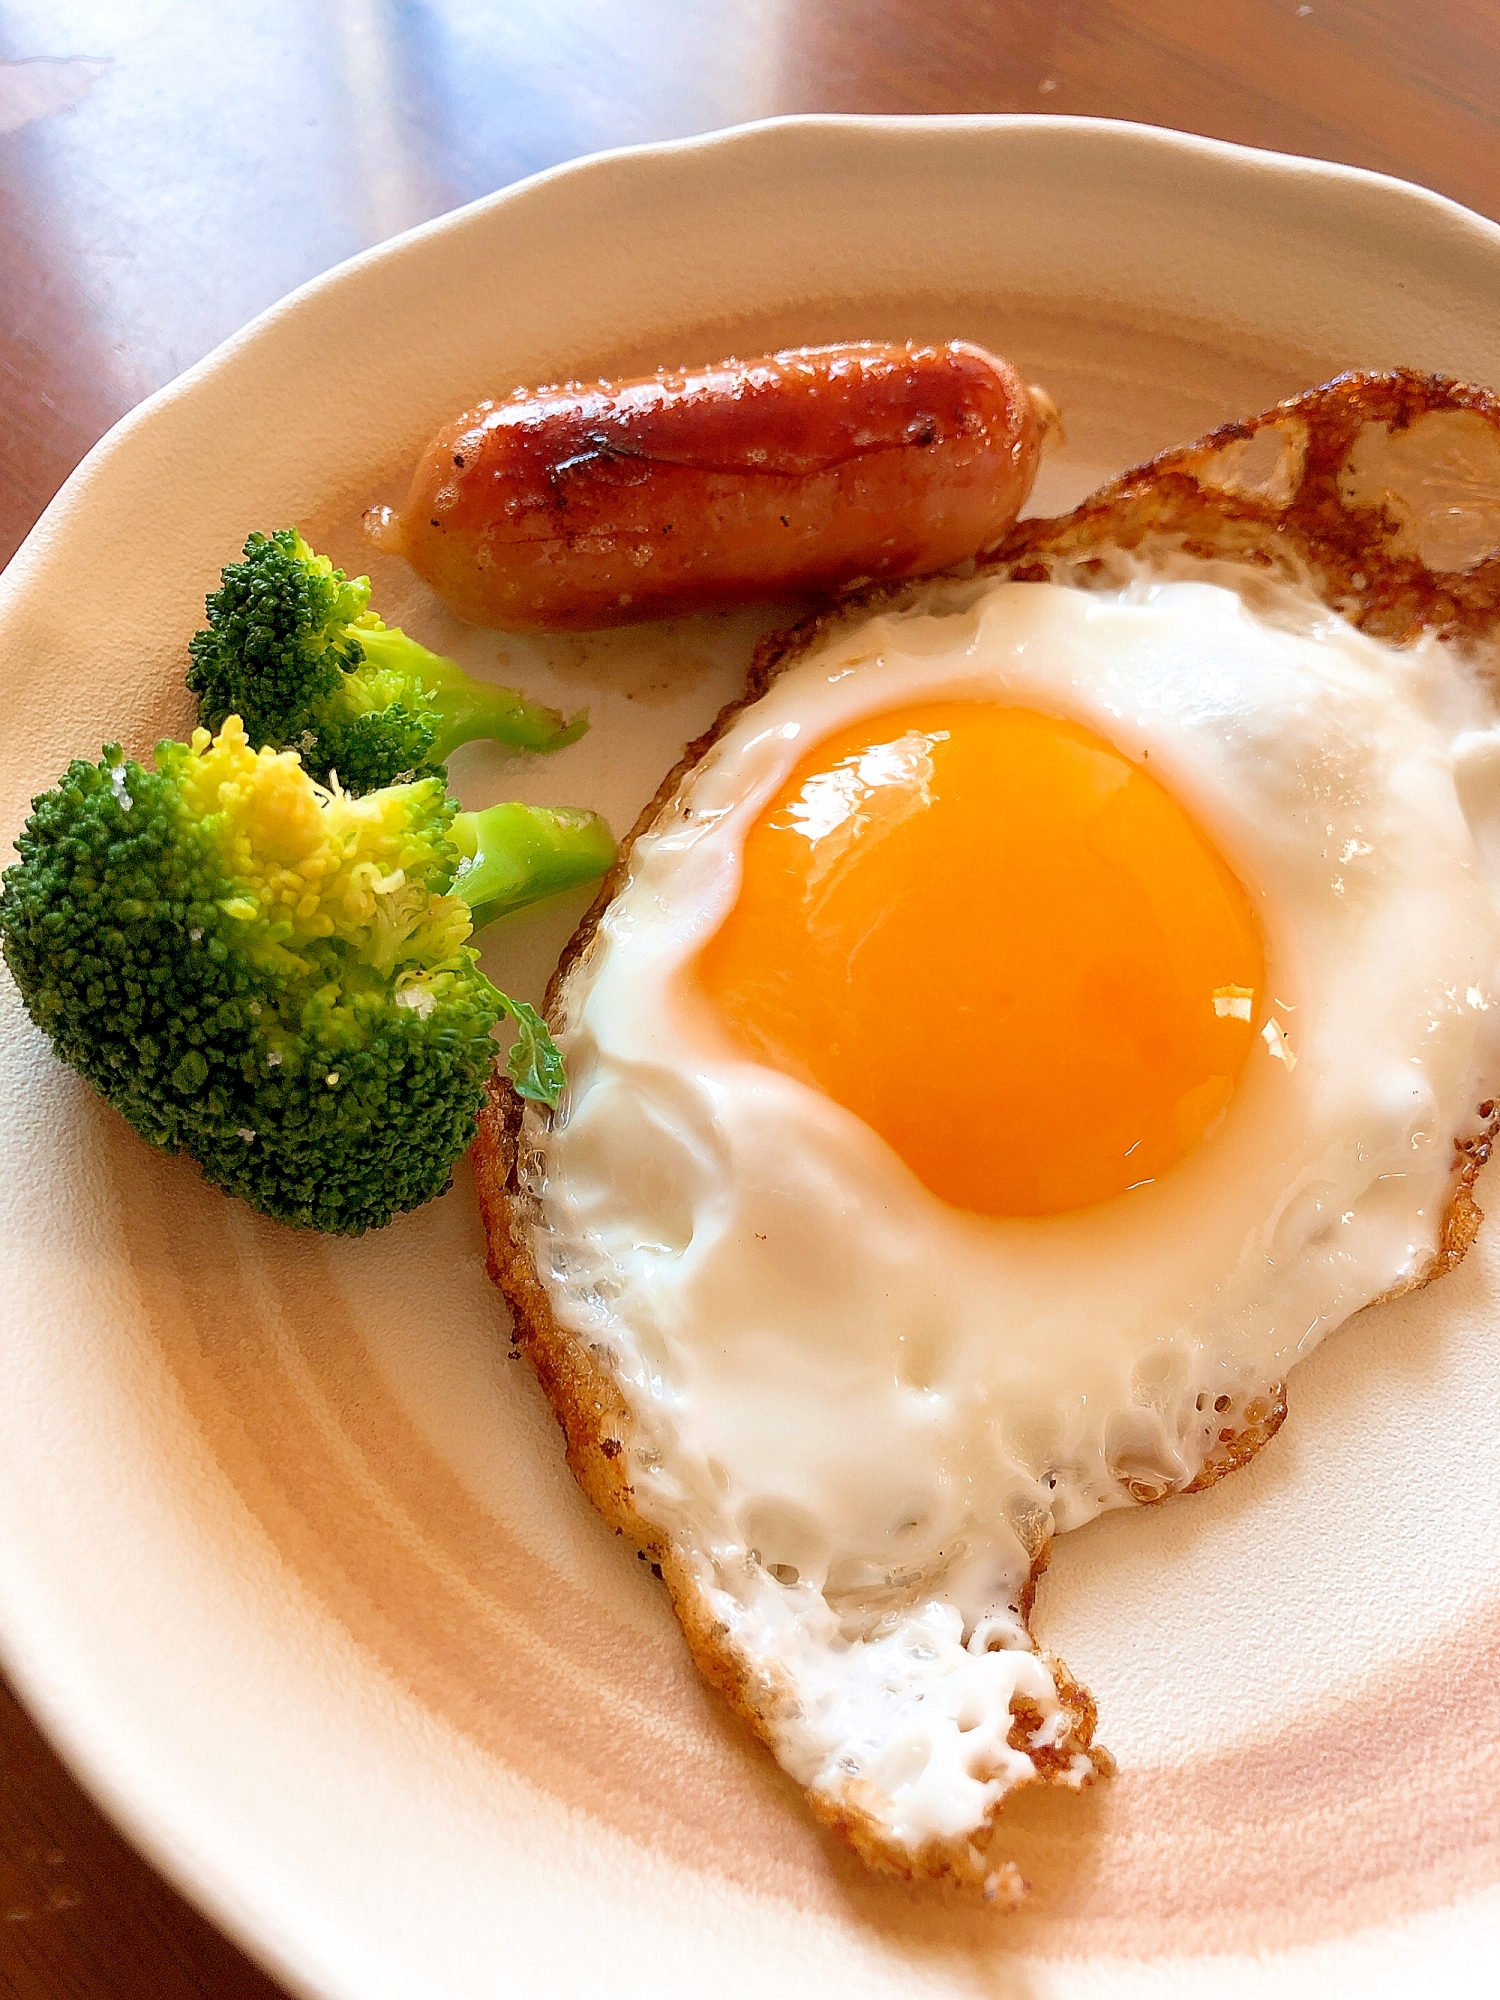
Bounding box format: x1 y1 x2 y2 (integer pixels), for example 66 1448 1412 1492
522 574 1500 1866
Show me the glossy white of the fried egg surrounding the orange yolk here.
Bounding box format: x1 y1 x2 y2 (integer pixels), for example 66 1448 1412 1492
526 578 1500 1850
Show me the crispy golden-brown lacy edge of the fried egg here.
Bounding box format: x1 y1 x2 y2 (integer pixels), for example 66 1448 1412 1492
474 370 1500 1904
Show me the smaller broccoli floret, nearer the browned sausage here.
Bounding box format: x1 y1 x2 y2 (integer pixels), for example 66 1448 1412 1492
188 528 588 794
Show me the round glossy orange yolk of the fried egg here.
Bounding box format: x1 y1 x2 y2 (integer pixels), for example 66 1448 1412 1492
698 700 1264 1216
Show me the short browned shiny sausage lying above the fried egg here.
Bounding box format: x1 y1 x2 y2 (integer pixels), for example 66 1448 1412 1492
366 340 1044 630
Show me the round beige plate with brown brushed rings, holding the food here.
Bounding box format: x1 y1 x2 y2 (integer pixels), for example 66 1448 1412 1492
0 118 1500 2000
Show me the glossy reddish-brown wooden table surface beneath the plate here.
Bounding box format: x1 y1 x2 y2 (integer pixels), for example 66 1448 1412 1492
0 0 1500 2000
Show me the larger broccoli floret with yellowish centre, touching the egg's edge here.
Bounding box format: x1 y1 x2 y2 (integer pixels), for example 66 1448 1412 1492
0 716 614 1236
